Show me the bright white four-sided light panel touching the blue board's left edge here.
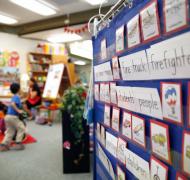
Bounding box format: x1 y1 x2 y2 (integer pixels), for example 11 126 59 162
69 40 93 60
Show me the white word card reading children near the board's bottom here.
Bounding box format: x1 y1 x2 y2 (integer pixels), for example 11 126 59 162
125 148 150 180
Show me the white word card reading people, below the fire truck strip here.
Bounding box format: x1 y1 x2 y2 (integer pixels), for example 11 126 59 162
117 86 163 119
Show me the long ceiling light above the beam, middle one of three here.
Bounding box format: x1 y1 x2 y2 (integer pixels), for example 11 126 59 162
10 0 56 16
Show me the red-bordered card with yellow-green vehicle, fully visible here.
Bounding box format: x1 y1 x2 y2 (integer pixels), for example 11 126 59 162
150 120 171 164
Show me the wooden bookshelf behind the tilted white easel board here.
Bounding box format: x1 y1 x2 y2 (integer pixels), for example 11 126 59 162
28 52 77 96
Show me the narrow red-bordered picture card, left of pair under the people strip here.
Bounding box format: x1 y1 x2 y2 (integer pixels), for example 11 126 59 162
122 111 132 139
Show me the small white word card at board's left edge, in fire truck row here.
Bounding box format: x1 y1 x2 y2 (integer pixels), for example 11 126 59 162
94 62 113 82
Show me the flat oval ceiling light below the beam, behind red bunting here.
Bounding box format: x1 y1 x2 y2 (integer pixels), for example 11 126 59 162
47 33 82 43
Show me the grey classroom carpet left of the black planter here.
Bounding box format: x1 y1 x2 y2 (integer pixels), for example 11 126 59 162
0 122 93 180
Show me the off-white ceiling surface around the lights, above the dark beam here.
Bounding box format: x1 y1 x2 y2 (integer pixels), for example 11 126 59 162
0 0 117 26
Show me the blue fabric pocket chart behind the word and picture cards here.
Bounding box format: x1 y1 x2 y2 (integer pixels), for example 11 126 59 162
93 0 190 180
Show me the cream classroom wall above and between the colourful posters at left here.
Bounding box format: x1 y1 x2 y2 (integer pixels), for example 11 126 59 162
0 32 38 73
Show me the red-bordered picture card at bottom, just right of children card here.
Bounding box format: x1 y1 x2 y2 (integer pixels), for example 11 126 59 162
150 156 168 180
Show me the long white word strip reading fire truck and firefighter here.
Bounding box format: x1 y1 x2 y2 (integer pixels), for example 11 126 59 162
119 32 190 81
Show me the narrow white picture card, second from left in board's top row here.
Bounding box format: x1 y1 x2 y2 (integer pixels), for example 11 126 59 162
115 25 124 53
